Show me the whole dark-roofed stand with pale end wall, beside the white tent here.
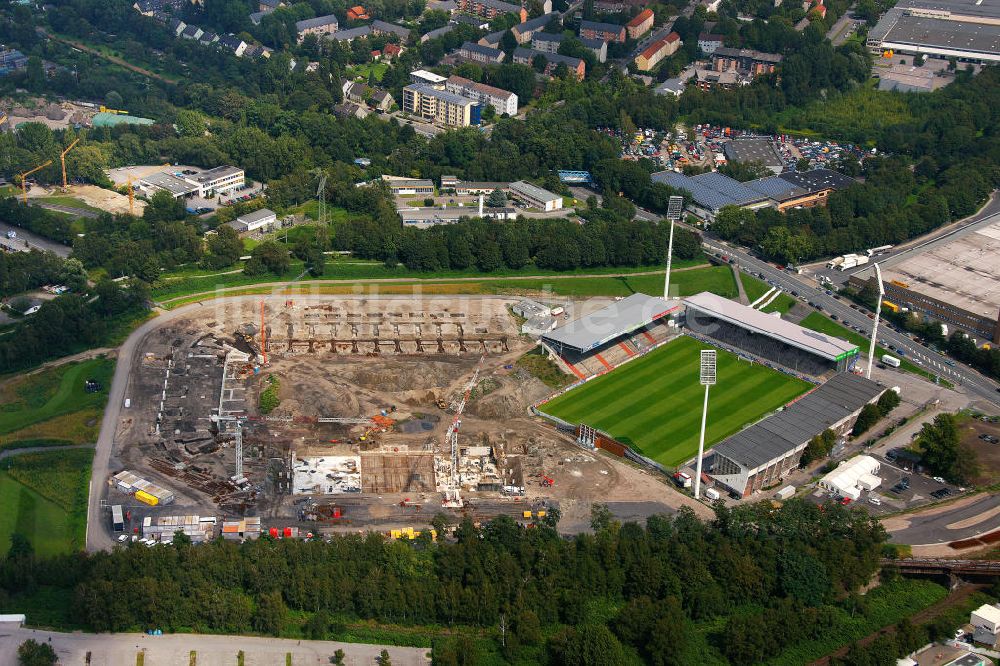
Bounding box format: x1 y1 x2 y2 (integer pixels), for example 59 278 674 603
706 370 885 497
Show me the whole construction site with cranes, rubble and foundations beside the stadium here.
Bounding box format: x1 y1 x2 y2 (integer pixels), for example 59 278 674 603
107 296 662 538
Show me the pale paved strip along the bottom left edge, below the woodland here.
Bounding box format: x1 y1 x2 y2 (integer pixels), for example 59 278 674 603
0 624 430 666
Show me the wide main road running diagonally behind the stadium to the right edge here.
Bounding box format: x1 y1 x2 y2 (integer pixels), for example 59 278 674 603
704 235 1000 405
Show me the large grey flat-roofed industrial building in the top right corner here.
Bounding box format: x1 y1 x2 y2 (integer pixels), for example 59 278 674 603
867 0 1000 64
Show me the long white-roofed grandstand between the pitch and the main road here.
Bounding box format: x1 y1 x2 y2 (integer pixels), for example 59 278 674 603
684 291 859 376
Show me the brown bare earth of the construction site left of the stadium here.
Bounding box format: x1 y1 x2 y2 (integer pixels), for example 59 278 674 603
105 296 712 532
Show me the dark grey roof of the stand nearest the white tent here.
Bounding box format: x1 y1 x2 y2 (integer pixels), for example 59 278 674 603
712 373 884 469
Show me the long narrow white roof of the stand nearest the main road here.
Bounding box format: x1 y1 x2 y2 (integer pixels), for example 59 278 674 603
684 291 858 361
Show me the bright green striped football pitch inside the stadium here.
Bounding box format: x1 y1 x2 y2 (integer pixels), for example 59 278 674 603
540 336 812 467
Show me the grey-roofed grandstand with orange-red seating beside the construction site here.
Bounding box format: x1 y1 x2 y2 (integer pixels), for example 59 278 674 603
541 294 680 379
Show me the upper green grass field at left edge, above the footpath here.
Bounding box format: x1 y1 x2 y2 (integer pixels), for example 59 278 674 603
0 358 115 449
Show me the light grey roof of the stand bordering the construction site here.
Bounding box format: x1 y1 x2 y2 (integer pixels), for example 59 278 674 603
543 294 677 352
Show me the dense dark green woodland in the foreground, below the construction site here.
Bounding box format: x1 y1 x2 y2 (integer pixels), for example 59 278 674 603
0 501 900 665
